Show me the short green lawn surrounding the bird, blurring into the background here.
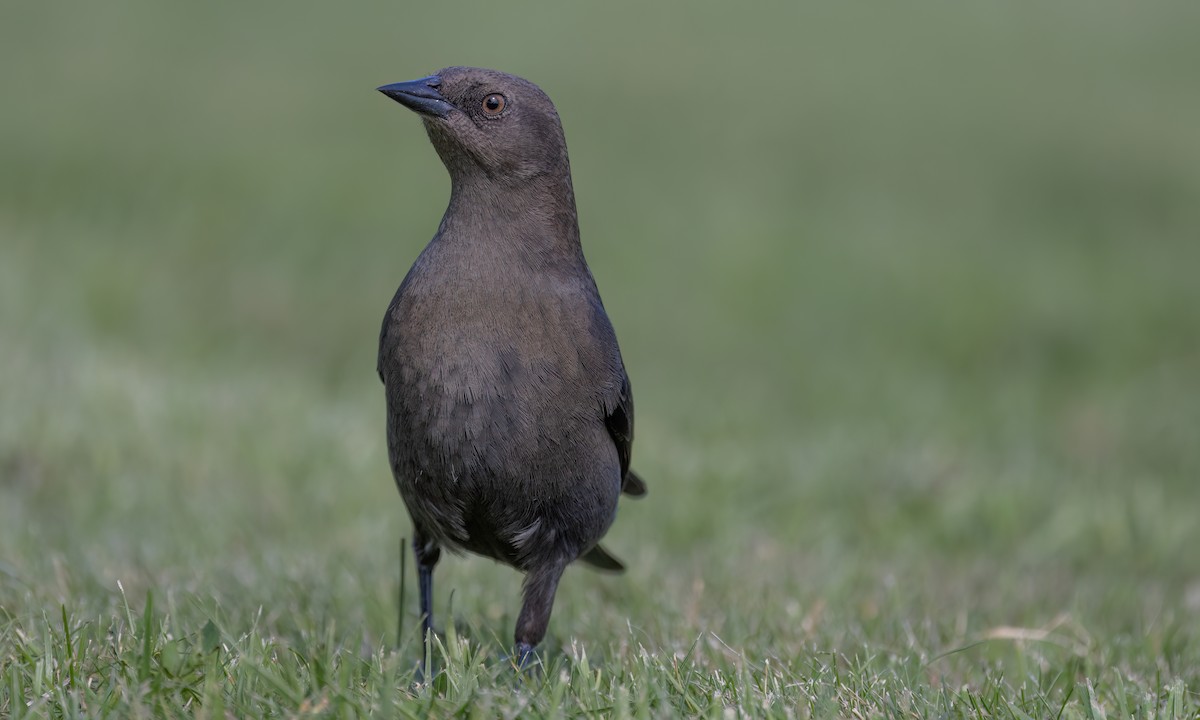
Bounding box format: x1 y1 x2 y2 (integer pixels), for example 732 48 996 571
0 0 1200 719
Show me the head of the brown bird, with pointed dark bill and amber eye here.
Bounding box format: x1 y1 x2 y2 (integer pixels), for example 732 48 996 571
379 67 570 185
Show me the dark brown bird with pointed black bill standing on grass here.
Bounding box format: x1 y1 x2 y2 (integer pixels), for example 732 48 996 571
378 67 646 665
